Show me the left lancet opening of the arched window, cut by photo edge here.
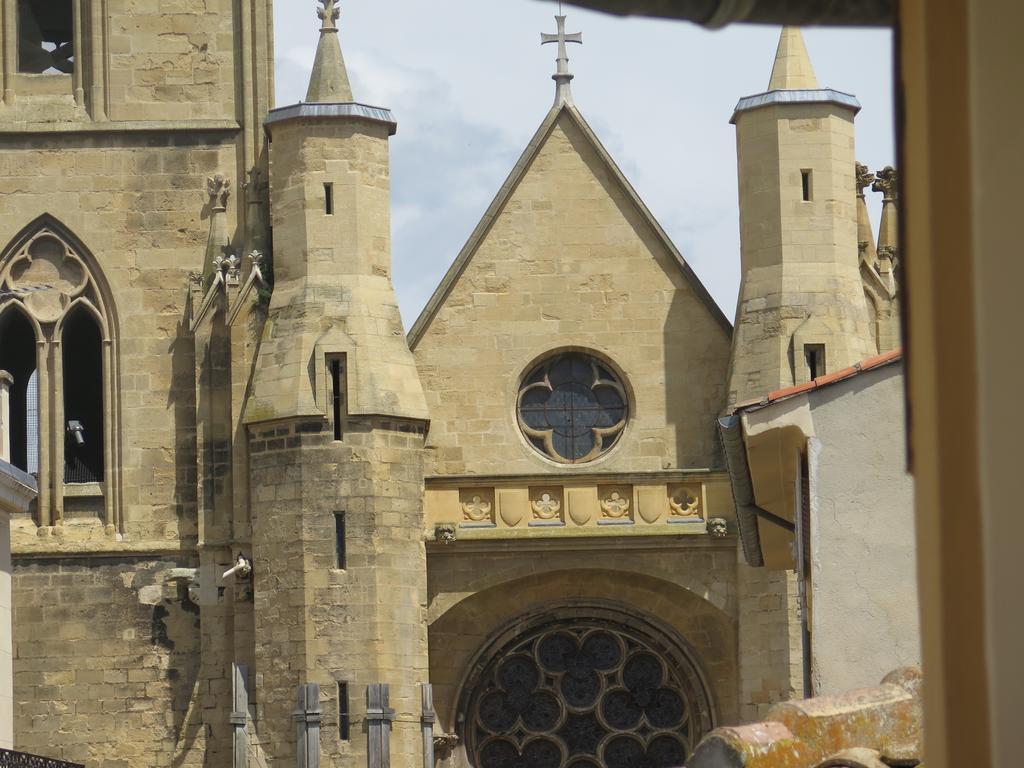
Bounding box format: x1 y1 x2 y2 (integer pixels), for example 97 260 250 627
0 309 39 473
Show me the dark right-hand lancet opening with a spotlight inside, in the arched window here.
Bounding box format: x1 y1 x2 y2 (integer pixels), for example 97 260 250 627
61 307 103 482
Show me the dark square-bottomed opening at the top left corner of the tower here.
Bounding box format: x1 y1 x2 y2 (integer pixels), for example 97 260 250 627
17 0 75 75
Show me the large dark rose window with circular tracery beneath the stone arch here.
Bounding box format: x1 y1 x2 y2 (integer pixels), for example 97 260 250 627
466 620 713 768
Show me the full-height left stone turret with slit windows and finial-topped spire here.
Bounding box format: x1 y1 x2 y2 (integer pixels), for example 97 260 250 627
246 0 428 768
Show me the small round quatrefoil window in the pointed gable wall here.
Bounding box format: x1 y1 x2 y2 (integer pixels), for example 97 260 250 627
518 352 629 464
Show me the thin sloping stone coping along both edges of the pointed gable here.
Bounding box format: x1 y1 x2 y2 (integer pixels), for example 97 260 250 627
409 103 732 350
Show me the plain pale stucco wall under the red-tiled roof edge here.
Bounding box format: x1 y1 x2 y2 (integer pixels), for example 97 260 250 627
808 362 921 695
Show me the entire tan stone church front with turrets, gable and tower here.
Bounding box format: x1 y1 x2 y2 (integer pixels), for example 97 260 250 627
0 0 898 768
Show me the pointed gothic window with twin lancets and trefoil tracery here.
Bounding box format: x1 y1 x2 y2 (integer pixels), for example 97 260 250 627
0 215 120 535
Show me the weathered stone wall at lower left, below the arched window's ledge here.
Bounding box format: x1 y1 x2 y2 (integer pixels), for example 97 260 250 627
13 557 206 768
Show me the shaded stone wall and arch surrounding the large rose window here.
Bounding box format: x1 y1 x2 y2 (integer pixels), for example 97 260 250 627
428 540 738 745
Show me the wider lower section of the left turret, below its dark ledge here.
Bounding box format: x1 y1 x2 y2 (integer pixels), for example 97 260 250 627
250 419 427 768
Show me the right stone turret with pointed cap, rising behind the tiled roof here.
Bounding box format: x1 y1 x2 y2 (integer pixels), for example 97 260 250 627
729 28 878 407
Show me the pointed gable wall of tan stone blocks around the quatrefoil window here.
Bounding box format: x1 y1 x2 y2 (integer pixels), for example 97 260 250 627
415 113 729 475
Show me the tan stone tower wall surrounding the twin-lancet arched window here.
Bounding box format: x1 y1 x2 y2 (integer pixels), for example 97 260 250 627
0 133 236 552
